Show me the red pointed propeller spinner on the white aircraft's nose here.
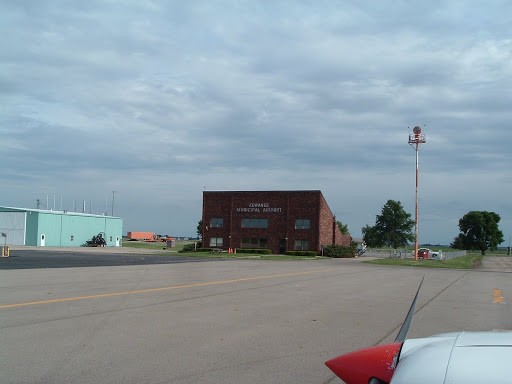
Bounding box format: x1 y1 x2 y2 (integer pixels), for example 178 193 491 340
325 343 402 384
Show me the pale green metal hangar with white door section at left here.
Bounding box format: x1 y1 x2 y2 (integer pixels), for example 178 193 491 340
0 206 123 247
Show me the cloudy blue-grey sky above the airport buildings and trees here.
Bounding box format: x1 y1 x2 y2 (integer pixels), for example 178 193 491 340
0 0 512 245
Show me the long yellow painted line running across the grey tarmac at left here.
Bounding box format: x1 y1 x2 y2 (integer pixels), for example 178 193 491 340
0 269 328 309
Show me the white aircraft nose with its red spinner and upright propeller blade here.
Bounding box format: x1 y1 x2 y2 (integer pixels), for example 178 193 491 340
325 279 512 384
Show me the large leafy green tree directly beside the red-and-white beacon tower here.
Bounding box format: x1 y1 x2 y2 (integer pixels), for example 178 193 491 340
362 200 414 248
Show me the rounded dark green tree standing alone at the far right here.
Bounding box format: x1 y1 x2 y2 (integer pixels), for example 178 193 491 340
454 211 503 255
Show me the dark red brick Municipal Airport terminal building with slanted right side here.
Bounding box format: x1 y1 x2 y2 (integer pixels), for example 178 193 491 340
203 191 350 254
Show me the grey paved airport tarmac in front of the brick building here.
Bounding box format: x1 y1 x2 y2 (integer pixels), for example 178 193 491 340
0 249 512 384
